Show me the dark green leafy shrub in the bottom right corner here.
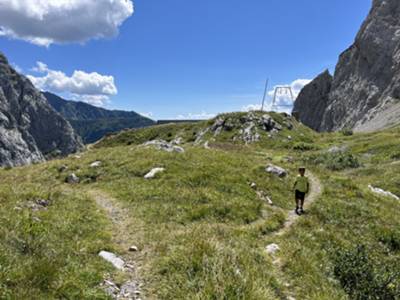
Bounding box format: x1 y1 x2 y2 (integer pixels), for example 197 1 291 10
334 245 399 300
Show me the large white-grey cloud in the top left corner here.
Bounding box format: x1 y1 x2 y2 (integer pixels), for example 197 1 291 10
0 0 134 47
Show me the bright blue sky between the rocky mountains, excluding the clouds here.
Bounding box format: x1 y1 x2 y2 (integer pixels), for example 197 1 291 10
0 0 371 119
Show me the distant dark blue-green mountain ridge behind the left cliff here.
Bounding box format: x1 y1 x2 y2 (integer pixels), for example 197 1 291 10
43 92 155 143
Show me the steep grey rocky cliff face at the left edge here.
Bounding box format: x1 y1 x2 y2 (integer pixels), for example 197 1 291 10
0 53 82 166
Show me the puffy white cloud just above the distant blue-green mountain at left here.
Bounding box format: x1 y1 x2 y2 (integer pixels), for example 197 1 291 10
27 62 118 106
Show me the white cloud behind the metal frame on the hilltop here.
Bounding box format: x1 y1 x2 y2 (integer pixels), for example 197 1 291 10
242 79 311 113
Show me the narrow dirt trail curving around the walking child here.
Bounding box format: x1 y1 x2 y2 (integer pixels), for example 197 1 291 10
274 172 322 236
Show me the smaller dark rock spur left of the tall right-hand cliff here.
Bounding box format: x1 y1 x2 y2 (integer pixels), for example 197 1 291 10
293 70 333 131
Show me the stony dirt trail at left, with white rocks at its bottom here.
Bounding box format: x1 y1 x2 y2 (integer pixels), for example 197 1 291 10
88 190 144 299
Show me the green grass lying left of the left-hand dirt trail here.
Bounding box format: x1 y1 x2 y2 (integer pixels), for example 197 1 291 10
0 164 113 299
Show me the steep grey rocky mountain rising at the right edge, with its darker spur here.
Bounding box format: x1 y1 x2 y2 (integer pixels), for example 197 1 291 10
294 0 400 131
